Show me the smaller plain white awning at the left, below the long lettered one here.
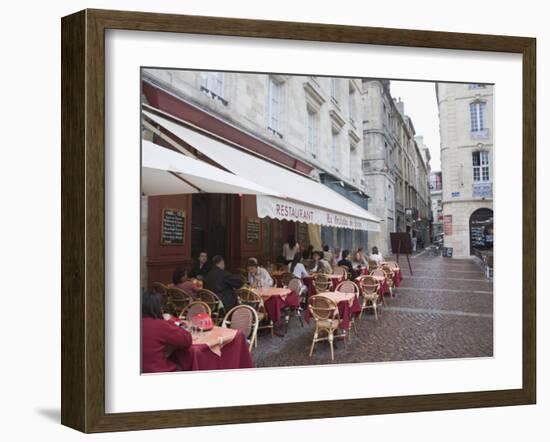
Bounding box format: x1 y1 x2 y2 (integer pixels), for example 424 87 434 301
141 140 278 196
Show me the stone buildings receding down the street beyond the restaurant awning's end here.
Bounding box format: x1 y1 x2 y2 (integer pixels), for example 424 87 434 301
363 79 431 253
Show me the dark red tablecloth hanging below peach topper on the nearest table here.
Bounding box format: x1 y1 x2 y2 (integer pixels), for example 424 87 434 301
173 332 254 371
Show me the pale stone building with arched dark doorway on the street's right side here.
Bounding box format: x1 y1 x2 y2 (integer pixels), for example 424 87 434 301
436 83 494 258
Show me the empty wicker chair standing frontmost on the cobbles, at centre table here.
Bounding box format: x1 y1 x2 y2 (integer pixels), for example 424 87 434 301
309 295 346 361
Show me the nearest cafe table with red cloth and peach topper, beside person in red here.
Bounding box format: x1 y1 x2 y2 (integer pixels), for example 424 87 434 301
173 320 254 371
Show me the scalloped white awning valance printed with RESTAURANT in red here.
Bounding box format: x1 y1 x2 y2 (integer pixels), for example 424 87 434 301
256 195 380 232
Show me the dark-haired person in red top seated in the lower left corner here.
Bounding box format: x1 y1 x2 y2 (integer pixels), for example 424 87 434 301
141 291 193 373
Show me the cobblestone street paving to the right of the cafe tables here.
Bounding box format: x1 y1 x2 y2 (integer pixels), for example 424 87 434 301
253 251 493 367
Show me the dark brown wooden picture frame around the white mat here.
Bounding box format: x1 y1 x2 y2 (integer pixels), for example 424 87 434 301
61 10 536 432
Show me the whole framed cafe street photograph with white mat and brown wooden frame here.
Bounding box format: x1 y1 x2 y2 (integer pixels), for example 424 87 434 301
62 10 536 432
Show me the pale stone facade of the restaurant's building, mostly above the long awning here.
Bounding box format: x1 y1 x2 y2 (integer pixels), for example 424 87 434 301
143 69 374 254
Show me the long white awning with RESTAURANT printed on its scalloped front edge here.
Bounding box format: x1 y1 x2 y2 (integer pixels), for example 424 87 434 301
143 111 381 231
